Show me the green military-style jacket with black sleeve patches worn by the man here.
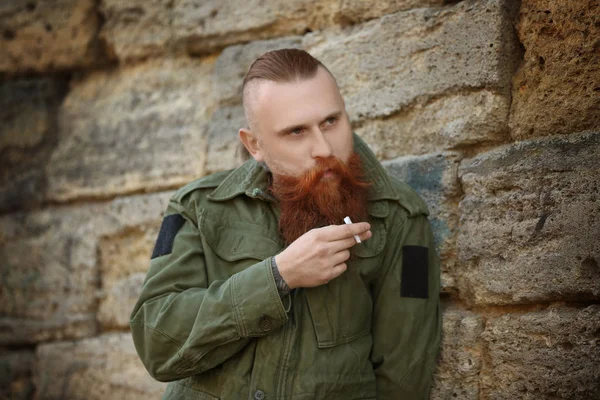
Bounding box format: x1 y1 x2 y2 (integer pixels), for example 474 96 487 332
130 136 441 400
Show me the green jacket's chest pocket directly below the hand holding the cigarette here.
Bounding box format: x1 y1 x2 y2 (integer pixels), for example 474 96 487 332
306 220 386 348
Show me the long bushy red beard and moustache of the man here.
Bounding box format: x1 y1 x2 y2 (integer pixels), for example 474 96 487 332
271 153 371 245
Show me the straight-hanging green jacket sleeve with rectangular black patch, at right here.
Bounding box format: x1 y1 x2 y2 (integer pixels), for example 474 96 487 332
371 215 441 400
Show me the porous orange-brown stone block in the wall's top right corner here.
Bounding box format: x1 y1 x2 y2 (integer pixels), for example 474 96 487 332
510 0 600 140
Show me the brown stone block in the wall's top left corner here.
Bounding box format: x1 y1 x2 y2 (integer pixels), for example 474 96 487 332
0 0 102 73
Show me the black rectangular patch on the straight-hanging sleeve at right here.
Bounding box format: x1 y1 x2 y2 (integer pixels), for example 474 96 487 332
400 246 429 299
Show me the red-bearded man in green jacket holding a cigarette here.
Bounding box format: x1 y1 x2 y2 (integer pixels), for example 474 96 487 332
130 49 441 400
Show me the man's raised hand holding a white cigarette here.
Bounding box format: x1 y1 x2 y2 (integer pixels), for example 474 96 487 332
275 222 371 289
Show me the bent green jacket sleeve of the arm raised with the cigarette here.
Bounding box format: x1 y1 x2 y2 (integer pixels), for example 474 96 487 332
130 201 288 382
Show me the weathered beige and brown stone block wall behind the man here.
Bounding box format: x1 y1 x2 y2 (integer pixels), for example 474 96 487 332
0 0 600 399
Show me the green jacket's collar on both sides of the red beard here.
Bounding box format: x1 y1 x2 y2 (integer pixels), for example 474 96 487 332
208 134 400 209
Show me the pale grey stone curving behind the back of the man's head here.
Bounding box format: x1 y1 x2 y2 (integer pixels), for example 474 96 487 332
213 36 302 106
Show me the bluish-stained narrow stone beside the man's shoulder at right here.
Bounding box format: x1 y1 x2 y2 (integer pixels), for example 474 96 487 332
383 153 460 292
